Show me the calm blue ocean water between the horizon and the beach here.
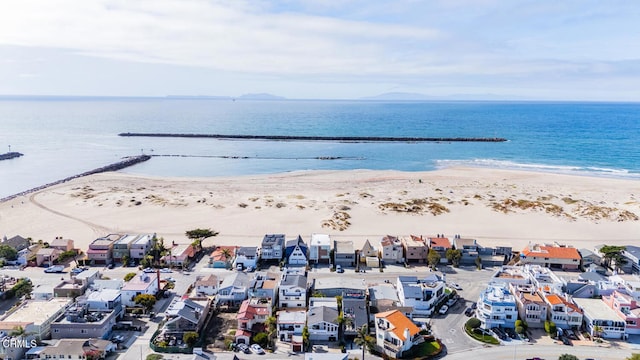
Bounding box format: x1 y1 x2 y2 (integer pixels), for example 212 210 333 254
0 99 640 197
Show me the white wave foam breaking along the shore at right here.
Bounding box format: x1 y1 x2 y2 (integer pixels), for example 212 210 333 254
434 159 640 179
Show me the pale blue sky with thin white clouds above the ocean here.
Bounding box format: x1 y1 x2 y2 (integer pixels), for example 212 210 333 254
0 0 640 101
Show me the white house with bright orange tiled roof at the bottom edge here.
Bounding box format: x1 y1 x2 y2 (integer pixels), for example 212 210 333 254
375 310 424 359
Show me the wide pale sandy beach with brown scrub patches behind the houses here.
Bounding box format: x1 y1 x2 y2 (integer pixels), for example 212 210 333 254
0 168 640 250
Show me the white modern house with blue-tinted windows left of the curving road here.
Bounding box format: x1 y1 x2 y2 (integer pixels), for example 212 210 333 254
396 274 446 316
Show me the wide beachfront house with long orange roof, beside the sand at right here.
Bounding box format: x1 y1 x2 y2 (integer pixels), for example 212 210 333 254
520 244 582 270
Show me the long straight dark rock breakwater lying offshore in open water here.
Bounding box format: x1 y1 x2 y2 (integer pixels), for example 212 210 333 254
118 132 507 142
